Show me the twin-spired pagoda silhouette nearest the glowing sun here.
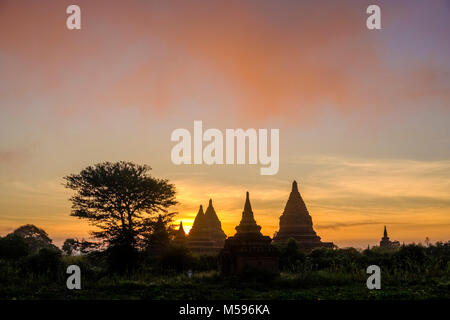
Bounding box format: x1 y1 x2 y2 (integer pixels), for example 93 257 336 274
187 199 226 253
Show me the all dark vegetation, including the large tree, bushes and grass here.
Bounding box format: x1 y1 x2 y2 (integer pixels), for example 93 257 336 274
0 162 450 299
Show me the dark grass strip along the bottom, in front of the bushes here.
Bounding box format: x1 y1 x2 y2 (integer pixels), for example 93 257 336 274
0 271 450 300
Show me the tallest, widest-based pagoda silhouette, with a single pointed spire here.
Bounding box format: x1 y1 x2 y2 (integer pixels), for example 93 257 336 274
273 181 334 251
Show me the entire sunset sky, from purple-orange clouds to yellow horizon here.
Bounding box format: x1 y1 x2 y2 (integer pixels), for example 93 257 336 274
0 0 450 247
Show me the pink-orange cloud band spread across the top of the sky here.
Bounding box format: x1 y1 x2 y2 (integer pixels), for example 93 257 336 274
0 0 450 123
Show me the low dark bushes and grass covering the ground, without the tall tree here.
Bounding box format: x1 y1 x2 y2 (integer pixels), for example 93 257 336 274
0 229 450 299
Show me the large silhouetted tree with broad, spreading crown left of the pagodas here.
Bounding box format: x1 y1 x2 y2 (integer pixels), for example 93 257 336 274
64 161 176 252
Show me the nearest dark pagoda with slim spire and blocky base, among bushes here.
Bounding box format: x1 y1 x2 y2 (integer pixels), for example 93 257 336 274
219 192 279 275
